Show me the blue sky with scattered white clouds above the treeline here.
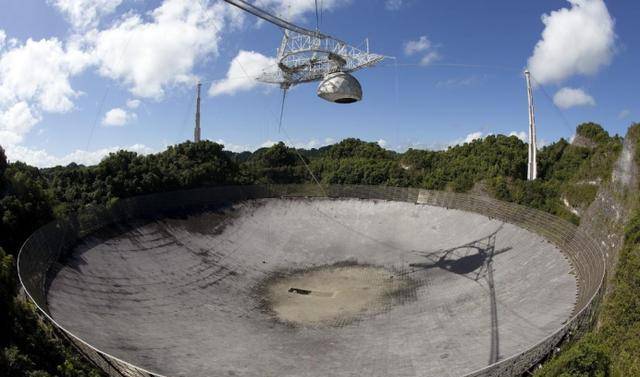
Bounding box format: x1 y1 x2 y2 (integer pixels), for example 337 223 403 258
0 0 640 166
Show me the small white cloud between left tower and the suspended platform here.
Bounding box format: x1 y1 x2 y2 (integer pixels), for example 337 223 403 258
209 50 276 96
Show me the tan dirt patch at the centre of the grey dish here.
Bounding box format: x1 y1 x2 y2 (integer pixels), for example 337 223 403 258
263 264 417 326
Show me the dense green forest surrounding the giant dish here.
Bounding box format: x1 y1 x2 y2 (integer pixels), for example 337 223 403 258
0 123 640 377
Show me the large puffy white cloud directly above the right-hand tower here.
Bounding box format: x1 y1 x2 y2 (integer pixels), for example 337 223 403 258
528 0 616 84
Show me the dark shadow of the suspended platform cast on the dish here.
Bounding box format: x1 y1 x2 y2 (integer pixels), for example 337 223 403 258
405 223 512 364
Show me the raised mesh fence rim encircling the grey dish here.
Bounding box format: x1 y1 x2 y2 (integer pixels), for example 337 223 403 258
18 185 605 377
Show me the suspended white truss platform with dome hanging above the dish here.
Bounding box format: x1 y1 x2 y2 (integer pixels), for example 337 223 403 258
225 0 385 103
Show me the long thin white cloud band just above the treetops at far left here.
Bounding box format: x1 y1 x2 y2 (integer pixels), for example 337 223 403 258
6 144 155 168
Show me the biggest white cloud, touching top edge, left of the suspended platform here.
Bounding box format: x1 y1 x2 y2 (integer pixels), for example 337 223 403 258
87 0 233 100
